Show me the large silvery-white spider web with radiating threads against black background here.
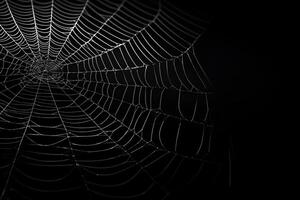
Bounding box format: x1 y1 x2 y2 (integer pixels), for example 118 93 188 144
0 0 216 199
